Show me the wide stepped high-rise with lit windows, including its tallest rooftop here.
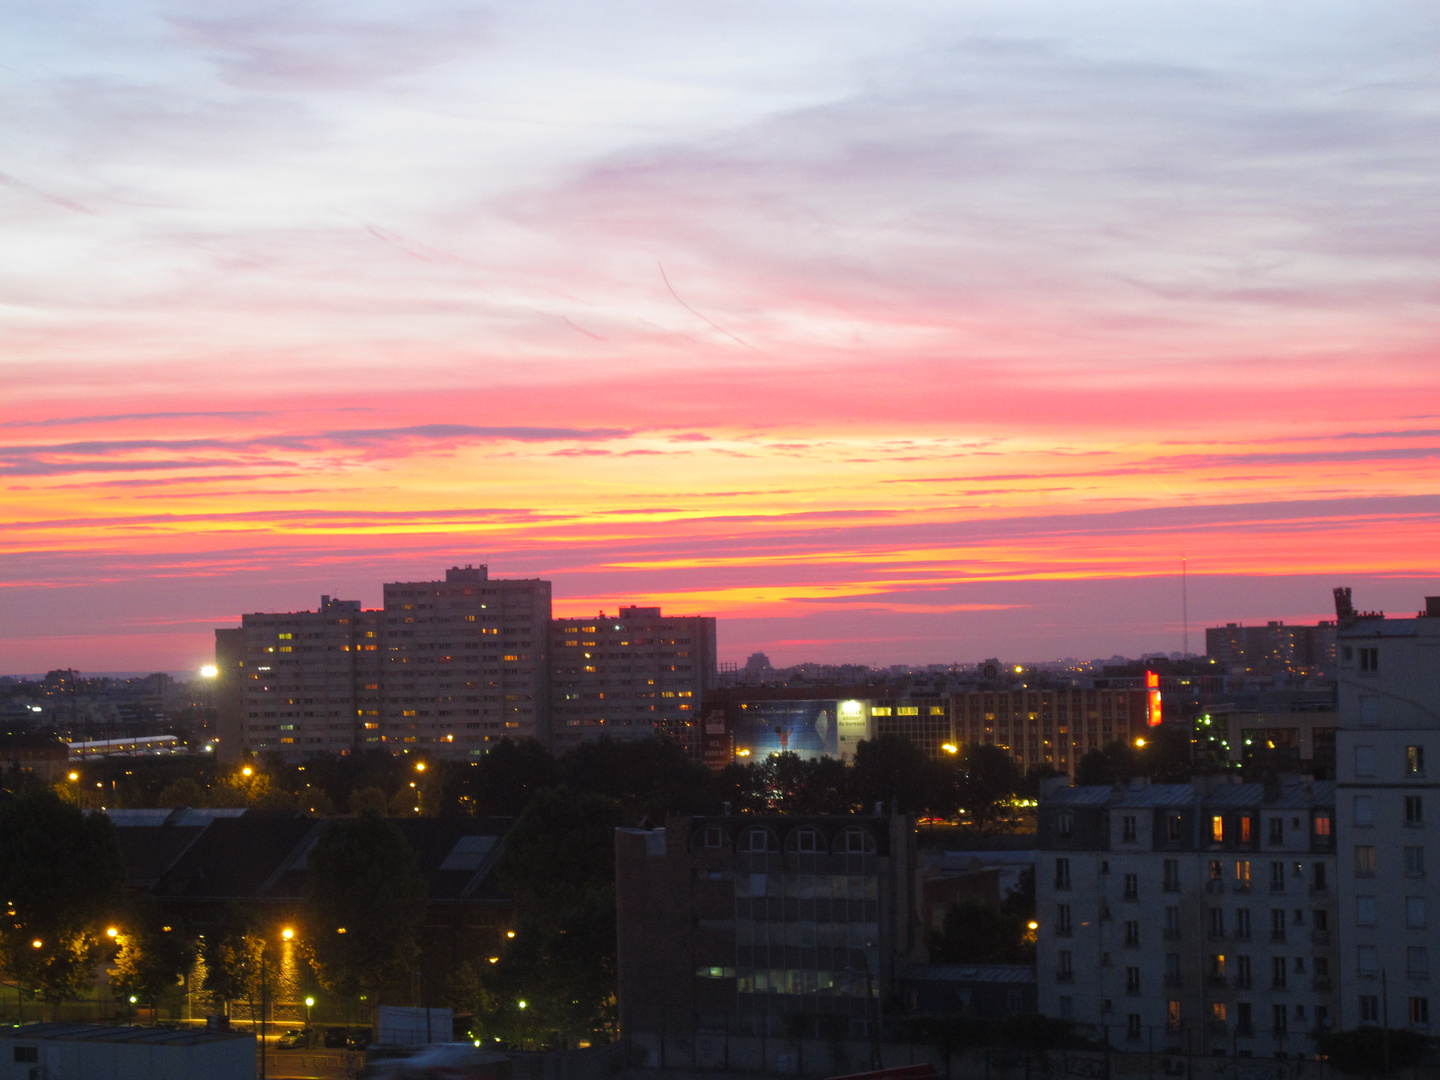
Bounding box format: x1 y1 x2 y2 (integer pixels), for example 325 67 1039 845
216 566 550 760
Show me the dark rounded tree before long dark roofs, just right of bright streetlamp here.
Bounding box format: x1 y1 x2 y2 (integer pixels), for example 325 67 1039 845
305 814 425 1004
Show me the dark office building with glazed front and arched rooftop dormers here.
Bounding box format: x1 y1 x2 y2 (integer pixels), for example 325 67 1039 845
615 815 923 1045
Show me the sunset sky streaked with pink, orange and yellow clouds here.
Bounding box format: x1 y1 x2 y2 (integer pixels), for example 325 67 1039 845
0 0 1440 672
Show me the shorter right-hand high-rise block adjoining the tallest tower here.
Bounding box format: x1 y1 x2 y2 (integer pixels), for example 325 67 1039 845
550 606 716 753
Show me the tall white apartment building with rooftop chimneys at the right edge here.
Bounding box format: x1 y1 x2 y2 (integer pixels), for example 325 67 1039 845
1336 589 1440 1032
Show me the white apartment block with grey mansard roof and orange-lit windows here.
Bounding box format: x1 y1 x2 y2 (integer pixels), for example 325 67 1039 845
1035 778 1338 1057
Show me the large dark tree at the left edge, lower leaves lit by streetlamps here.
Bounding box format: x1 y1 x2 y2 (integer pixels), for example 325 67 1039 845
0 789 125 1007
